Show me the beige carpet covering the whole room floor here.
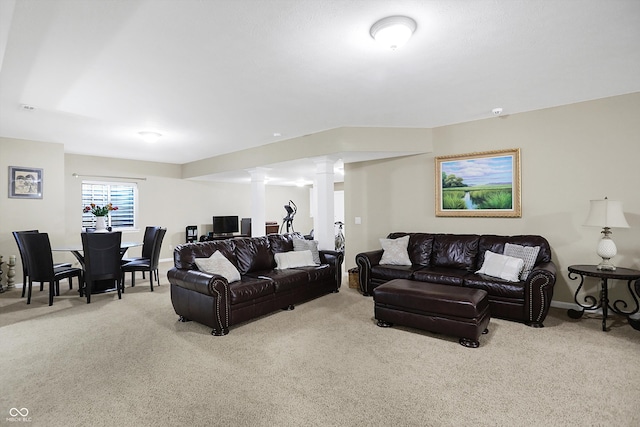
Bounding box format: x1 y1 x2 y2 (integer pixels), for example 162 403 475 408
0 265 640 426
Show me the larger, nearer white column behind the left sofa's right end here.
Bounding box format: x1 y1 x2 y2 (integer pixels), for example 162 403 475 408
313 156 336 250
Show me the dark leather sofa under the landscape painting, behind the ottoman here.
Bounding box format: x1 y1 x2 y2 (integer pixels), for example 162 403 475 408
356 233 556 327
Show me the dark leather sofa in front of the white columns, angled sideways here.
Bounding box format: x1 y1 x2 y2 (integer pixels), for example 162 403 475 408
167 234 344 335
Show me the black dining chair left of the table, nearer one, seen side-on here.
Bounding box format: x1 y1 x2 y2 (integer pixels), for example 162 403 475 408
21 233 82 305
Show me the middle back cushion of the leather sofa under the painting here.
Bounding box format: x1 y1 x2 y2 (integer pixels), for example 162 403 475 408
432 234 480 271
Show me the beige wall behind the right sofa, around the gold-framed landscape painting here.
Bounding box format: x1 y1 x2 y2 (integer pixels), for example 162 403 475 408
345 93 640 302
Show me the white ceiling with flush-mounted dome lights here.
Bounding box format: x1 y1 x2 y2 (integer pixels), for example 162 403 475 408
0 0 640 184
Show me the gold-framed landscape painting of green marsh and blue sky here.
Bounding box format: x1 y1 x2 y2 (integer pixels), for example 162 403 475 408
435 149 522 218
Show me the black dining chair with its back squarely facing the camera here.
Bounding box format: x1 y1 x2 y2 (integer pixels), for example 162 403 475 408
80 231 123 304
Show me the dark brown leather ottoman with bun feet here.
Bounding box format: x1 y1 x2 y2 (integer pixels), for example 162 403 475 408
373 279 491 348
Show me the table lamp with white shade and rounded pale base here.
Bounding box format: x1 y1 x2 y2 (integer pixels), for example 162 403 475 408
584 197 629 270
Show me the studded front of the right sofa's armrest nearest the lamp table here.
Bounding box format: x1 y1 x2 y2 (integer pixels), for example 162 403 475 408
524 261 556 328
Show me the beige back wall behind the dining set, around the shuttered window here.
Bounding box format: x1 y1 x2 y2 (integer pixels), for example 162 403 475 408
0 138 313 283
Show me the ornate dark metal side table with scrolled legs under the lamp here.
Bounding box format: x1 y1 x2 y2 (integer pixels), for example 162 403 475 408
567 265 640 332
